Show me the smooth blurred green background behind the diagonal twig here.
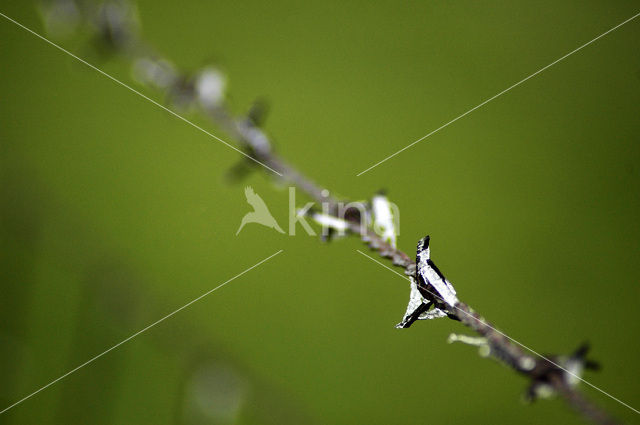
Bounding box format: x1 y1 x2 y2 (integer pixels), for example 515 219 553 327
0 0 640 424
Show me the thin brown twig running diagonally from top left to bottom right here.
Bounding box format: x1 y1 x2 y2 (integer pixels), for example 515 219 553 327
37 0 619 424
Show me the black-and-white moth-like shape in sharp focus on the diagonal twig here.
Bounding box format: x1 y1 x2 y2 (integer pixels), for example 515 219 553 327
396 236 458 328
